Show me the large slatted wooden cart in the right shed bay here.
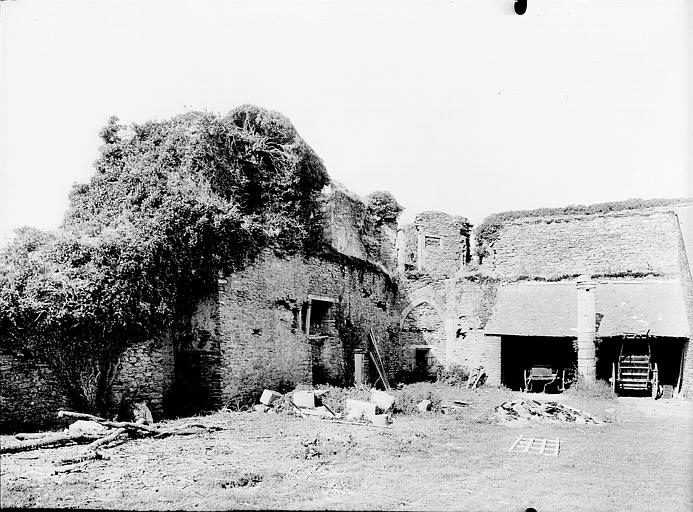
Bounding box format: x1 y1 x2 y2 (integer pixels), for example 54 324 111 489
611 338 661 399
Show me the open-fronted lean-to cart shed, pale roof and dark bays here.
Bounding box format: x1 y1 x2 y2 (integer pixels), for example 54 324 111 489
485 279 690 396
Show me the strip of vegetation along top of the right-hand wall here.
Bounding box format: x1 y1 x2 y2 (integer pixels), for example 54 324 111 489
474 198 693 257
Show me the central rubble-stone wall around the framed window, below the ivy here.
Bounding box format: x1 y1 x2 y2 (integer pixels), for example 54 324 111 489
218 254 402 401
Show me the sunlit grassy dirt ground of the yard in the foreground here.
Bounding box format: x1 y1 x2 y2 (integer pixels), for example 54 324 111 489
0 389 693 511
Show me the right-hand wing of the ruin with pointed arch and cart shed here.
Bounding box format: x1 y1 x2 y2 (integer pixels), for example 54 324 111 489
397 204 693 394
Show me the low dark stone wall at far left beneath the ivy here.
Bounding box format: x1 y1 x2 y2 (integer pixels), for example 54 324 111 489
0 354 69 433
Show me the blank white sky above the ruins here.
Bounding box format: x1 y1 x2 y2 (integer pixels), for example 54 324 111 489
0 0 693 246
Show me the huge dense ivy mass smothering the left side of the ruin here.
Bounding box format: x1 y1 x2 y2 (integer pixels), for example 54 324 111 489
0 105 329 409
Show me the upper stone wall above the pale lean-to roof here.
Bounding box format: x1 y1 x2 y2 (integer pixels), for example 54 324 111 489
484 209 679 279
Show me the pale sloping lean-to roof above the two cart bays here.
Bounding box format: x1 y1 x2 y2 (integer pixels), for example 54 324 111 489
485 281 690 338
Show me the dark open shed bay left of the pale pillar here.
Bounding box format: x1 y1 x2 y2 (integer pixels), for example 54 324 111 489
501 336 577 391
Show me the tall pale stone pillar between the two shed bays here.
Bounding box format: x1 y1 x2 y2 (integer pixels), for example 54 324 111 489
576 275 597 382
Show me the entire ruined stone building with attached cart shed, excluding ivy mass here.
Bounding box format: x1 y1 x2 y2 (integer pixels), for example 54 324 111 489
0 187 693 430
